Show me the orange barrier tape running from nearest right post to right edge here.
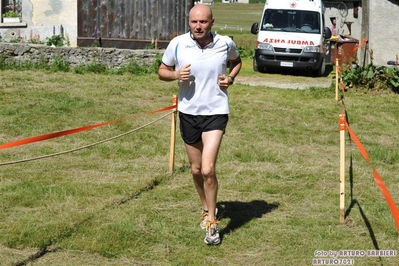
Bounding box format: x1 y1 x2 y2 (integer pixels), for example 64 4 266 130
345 116 399 231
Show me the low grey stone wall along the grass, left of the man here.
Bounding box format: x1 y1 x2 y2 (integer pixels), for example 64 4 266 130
0 42 163 69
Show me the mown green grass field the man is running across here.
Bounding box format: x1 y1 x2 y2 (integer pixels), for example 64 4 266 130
0 2 399 266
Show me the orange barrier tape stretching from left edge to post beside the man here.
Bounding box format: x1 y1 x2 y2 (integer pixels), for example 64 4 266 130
0 104 177 150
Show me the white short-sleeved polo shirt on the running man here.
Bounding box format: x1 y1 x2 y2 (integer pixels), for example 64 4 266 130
162 32 239 115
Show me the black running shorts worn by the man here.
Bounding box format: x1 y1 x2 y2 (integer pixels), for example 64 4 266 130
179 112 229 144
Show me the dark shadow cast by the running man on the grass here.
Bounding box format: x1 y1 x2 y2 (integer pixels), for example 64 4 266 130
217 200 279 239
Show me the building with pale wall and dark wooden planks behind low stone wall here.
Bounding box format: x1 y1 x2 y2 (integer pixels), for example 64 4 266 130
0 0 194 49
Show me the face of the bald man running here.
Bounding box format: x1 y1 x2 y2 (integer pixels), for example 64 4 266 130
189 9 214 41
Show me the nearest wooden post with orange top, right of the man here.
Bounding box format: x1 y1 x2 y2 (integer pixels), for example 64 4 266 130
339 113 346 223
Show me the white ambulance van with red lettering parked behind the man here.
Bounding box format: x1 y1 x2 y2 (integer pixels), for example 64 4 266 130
251 0 331 76
